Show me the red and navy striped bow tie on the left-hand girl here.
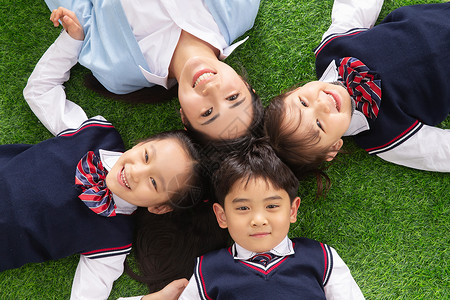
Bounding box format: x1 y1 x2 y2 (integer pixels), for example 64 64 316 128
75 151 116 217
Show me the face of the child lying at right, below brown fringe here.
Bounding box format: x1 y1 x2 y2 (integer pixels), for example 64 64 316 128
283 81 352 154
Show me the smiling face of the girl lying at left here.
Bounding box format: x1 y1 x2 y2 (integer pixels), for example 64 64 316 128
106 138 192 213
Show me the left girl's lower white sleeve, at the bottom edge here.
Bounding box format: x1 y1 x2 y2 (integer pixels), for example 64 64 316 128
70 254 127 300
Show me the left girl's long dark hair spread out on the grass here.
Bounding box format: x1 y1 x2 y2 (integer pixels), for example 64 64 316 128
125 130 231 292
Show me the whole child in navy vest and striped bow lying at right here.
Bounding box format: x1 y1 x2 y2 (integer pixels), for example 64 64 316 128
265 0 450 175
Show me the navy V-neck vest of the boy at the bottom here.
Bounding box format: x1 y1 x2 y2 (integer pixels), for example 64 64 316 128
194 238 333 300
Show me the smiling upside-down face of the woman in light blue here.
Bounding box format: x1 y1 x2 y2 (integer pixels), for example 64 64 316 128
178 57 253 140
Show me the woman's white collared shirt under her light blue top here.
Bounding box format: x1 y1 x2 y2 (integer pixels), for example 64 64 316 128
121 0 246 88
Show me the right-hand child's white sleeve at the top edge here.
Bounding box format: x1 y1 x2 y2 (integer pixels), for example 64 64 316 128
322 0 383 40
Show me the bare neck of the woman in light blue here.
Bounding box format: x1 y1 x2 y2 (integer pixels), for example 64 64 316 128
169 30 220 81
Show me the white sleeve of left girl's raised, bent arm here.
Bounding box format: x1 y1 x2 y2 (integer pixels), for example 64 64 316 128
23 31 87 135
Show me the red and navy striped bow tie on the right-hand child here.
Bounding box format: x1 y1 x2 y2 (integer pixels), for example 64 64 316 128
336 57 381 120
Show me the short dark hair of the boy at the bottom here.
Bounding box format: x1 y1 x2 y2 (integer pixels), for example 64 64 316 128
212 139 299 206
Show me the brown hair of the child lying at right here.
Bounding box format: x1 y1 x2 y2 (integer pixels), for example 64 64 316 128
264 91 330 194
